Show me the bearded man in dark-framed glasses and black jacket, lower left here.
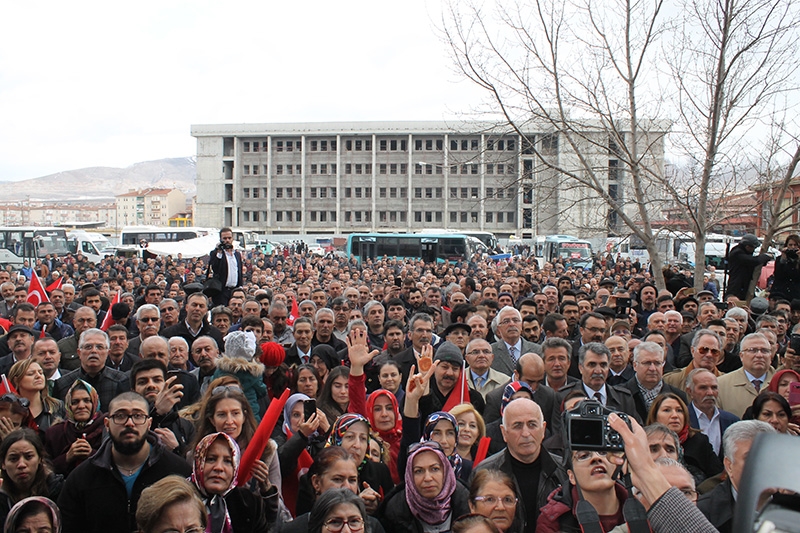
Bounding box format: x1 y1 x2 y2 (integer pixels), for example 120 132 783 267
58 392 191 533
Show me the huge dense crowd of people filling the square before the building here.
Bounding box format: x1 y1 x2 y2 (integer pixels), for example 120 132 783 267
0 228 800 533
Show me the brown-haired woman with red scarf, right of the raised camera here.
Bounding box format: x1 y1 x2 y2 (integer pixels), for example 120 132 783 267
647 392 722 485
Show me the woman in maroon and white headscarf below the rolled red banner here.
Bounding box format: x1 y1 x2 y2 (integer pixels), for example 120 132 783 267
191 432 278 533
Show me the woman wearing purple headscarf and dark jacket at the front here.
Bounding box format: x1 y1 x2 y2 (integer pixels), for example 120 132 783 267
382 441 470 533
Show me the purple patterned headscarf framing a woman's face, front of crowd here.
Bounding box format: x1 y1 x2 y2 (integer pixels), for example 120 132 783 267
405 441 457 525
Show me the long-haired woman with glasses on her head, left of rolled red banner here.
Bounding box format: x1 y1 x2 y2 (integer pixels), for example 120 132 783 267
194 376 281 492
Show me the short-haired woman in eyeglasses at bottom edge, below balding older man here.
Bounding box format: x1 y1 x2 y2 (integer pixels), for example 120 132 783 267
469 469 522 533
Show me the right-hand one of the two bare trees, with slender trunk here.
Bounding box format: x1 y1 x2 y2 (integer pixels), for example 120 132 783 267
665 0 798 289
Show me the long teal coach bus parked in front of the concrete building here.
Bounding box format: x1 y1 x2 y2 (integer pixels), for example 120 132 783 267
347 233 489 263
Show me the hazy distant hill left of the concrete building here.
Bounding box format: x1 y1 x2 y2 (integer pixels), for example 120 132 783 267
0 157 197 202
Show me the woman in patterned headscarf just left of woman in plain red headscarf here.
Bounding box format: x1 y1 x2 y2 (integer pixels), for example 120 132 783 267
297 413 394 515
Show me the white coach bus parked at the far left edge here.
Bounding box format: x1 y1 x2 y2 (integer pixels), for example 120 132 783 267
0 226 70 268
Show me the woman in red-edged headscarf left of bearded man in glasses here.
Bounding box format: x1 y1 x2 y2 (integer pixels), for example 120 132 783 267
44 379 106 477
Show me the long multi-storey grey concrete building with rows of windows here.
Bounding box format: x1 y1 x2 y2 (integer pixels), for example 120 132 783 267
191 122 663 238
